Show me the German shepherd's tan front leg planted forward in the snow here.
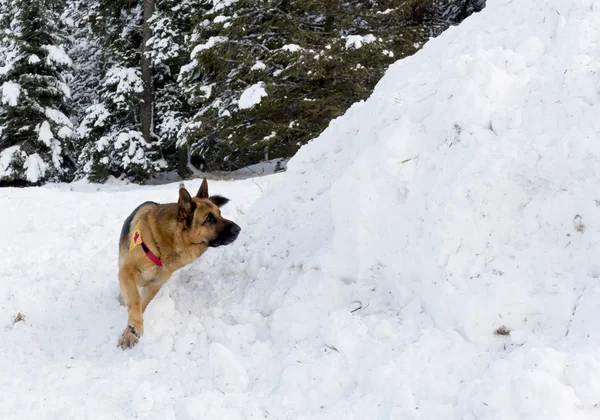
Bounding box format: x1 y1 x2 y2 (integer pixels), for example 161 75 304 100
119 263 144 350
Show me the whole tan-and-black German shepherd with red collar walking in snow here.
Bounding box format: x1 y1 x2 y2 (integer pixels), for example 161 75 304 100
119 177 241 349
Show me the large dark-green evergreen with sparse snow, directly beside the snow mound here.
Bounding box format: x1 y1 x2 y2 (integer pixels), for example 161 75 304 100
180 0 480 170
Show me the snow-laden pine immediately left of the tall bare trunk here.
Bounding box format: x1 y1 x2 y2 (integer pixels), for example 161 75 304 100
77 0 166 182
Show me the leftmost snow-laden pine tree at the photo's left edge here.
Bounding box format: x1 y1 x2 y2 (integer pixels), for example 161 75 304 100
0 0 74 185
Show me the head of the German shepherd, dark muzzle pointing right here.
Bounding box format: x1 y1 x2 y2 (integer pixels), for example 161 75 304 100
177 177 241 247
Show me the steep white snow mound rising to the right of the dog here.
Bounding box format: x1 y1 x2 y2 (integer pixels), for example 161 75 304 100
195 0 600 420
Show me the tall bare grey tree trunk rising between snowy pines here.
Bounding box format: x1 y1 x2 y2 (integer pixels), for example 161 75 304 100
140 0 154 143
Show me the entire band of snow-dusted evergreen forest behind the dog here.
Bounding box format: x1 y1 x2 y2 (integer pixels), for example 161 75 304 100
0 0 485 184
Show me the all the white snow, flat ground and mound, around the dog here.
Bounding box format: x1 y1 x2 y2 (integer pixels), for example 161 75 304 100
0 0 600 420
